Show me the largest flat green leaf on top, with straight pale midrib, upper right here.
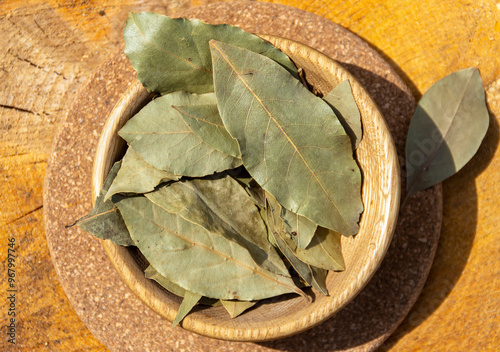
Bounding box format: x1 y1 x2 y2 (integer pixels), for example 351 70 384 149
210 41 363 235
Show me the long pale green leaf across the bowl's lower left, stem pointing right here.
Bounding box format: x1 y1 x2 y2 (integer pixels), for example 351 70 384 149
115 195 305 301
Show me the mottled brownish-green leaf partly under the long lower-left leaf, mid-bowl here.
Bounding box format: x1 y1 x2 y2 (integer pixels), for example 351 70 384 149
146 176 289 276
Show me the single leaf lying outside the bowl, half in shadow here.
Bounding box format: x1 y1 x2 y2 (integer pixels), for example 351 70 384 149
406 68 489 196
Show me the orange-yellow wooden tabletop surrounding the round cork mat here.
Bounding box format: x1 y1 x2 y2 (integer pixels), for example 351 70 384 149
0 0 500 351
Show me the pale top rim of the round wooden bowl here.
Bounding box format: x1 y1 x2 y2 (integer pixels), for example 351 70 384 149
92 35 401 342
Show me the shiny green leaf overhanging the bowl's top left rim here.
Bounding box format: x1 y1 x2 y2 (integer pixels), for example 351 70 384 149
123 12 297 94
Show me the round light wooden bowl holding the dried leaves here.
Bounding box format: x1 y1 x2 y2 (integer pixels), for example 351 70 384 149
92 36 400 341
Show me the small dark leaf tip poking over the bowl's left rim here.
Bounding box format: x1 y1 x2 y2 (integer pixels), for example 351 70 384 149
74 161 134 246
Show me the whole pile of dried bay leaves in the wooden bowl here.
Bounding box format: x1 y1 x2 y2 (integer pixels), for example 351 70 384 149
76 13 488 326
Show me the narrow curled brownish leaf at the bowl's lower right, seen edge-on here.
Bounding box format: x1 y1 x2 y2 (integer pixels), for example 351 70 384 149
267 195 328 296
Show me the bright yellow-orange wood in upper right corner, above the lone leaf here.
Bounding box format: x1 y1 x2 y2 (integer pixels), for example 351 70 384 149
271 0 500 96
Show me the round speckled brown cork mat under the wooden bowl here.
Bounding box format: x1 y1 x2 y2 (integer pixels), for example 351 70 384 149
44 2 442 351
